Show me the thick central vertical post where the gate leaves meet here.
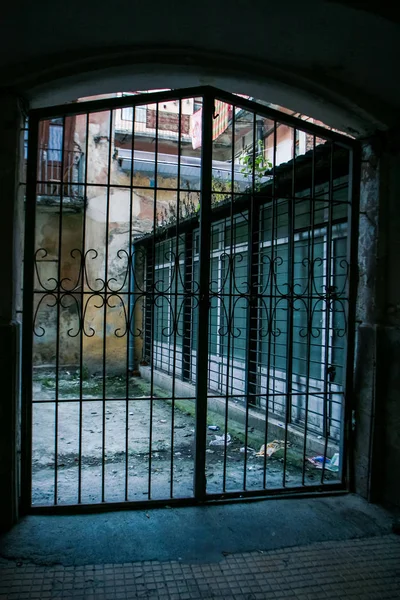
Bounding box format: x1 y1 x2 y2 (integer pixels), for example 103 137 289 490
194 93 214 500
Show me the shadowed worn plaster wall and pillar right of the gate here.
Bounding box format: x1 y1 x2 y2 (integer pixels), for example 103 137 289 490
353 132 400 506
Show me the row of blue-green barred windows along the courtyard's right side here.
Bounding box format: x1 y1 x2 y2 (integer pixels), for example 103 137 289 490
145 177 347 430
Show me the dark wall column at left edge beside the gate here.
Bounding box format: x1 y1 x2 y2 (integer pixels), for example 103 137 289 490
0 95 24 531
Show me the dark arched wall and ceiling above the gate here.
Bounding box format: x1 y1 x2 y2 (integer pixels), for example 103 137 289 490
0 0 400 135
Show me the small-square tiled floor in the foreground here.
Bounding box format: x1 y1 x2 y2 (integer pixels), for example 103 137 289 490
0 535 400 600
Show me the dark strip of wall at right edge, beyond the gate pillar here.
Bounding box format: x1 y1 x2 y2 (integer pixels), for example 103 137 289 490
374 136 400 506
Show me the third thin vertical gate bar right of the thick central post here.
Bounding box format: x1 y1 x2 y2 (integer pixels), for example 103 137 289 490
260 121 277 489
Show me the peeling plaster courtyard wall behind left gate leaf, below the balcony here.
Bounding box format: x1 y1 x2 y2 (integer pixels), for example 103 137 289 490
34 171 184 375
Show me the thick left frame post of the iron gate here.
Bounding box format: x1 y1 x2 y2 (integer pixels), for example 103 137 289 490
21 111 39 513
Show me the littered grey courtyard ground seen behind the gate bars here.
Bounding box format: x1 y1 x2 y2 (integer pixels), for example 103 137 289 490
32 370 337 505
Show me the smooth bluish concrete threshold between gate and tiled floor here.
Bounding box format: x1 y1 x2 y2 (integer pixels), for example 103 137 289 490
0 494 392 566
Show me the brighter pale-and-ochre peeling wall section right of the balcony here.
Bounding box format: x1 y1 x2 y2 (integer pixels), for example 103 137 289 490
83 170 186 374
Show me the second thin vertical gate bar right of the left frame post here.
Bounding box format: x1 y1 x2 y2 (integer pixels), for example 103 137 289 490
78 113 89 504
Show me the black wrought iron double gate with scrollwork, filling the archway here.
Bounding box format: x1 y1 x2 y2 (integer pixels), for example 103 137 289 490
22 88 358 511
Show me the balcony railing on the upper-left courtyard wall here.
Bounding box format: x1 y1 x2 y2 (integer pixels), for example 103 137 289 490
37 148 84 199
